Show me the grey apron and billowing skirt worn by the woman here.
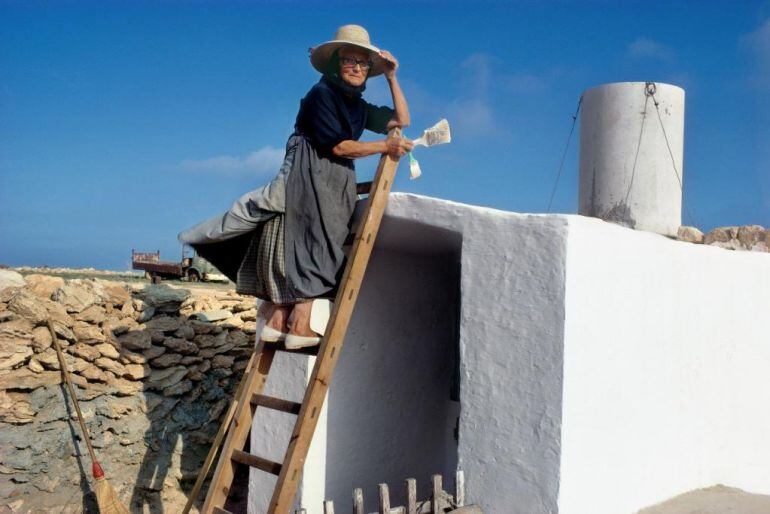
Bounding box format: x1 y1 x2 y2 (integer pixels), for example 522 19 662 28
179 134 356 304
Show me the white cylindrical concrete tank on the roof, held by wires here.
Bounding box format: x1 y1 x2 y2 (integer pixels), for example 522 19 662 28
579 82 684 236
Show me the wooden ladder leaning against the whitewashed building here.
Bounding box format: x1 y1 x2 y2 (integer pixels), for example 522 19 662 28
183 128 401 514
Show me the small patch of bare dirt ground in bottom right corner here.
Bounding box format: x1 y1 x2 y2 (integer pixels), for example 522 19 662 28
638 485 770 514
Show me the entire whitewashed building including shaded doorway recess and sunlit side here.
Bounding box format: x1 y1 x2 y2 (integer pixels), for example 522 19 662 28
250 193 770 514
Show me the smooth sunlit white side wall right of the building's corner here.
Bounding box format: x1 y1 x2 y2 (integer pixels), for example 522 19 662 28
559 217 770 514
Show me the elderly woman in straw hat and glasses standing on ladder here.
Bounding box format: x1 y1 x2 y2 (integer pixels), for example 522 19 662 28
179 25 412 348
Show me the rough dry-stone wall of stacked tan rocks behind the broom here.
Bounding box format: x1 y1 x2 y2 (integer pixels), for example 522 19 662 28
0 270 256 512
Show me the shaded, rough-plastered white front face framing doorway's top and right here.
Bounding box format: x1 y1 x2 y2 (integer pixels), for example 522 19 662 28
387 194 567 514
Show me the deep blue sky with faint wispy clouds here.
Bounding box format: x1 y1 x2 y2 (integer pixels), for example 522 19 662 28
0 0 770 269
